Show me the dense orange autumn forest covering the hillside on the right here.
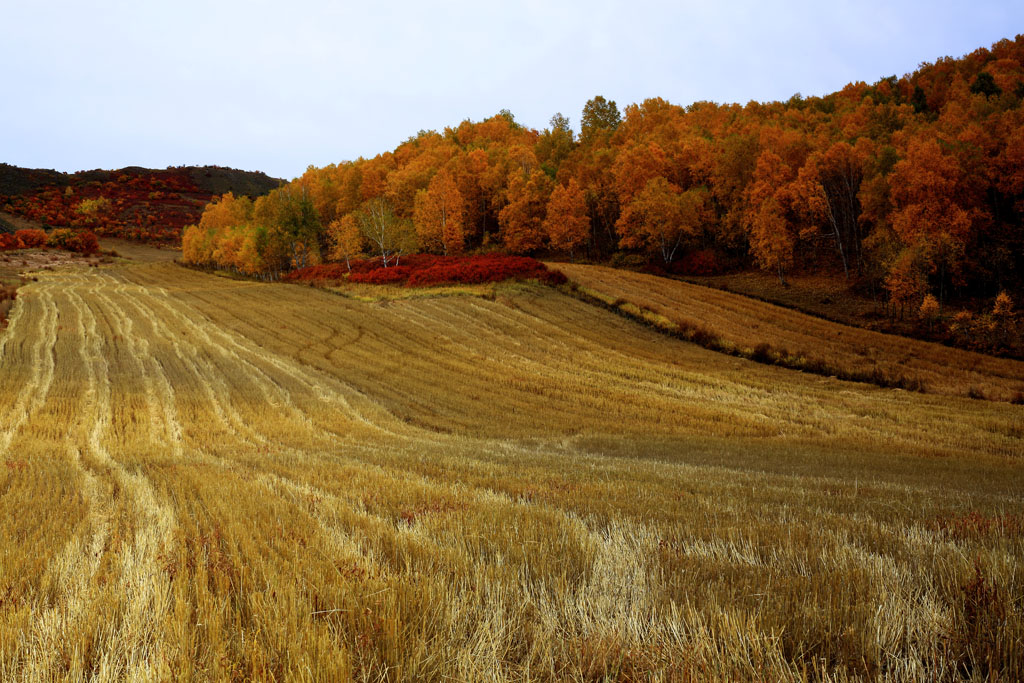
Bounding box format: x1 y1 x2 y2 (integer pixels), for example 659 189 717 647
184 36 1024 307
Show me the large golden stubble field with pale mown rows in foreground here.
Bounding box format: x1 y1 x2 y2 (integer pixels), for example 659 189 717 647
0 263 1024 681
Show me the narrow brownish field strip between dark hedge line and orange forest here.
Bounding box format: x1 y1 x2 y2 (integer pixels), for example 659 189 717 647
557 264 1024 401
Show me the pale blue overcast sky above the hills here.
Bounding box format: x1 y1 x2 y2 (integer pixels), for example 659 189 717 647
0 0 1024 179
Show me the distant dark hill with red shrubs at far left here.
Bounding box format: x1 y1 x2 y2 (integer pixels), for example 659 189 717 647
0 164 283 242
